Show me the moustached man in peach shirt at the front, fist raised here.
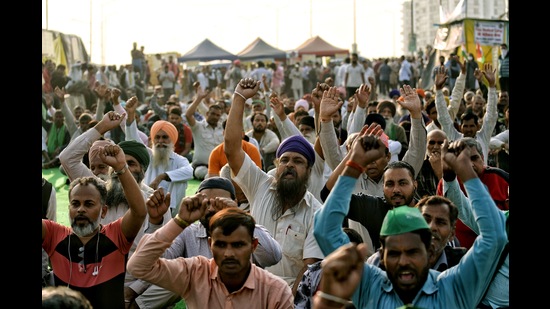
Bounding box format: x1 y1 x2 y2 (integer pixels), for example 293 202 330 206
128 189 293 309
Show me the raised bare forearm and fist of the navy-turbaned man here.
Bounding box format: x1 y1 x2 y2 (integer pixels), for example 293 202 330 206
226 78 266 175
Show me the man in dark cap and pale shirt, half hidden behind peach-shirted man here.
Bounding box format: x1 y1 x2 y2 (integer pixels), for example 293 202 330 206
127 177 282 308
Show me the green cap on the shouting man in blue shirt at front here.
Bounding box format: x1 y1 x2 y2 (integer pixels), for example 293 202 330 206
380 206 430 236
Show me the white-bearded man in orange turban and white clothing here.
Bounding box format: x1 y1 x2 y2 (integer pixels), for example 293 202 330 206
125 103 193 219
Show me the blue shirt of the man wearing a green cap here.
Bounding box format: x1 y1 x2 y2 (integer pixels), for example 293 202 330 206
313 176 507 309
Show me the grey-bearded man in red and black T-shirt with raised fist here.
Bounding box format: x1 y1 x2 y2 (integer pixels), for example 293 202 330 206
42 145 147 308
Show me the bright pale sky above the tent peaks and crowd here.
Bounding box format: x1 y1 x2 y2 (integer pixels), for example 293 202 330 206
42 0 403 65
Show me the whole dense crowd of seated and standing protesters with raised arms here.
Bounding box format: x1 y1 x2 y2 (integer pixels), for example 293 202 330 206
42 43 510 309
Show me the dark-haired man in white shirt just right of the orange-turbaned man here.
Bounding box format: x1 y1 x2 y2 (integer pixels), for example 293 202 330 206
185 85 225 180
